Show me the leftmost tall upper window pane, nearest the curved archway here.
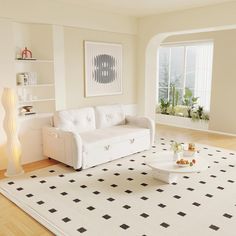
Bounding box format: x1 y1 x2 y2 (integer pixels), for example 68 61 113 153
159 47 170 87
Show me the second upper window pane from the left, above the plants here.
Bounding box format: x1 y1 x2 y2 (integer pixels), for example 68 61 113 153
170 47 184 88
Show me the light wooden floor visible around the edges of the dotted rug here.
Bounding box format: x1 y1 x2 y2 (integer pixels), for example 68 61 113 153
0 125 236 236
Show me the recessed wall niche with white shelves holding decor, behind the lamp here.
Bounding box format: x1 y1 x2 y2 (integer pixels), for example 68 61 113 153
13 23 56 114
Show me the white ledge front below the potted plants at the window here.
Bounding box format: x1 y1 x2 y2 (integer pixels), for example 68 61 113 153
156 113 209 130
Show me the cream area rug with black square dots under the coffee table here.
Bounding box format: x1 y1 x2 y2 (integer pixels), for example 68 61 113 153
0 138 236 236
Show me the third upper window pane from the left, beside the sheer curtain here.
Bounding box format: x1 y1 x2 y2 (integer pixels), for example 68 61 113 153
185 46 197 89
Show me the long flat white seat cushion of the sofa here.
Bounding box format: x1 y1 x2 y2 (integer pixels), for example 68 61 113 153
80 125 150 150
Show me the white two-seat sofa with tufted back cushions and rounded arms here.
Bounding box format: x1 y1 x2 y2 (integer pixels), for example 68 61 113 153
43 105 155 169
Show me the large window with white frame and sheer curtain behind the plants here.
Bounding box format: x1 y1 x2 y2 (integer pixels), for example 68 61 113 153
157 42 213 111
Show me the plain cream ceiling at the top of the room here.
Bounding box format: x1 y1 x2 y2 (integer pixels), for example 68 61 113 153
52 0 232 17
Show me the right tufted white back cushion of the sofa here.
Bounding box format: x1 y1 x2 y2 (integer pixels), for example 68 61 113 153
95 105 125 129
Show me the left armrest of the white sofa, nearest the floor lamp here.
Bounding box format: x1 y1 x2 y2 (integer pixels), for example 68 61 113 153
43 126 83 169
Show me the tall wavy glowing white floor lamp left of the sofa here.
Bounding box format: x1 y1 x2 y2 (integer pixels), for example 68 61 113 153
2 88 24 177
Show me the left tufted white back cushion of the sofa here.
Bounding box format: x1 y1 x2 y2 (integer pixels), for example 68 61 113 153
54 107 96 133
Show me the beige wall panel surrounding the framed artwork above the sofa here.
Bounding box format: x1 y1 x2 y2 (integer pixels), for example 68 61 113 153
64 27 137 108
